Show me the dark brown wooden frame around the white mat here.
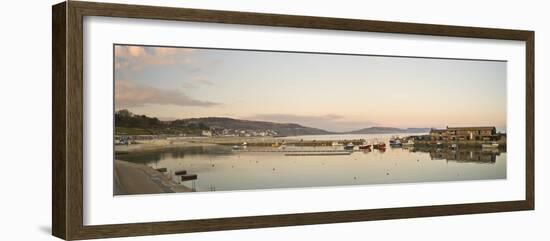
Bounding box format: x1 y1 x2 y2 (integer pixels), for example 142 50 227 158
52 1 535 240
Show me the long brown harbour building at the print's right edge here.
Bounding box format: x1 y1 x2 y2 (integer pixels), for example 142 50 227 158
430 126 499 141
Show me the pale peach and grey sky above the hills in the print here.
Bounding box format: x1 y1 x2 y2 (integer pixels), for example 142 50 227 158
114 45 506 131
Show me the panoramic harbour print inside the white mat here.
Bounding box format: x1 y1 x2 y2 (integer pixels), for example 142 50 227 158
113 44 507 195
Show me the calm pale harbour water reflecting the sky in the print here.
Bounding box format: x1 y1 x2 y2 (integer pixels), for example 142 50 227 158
117 134 506 191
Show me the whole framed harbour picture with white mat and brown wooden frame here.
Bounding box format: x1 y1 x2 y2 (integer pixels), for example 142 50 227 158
52 1 534 240
